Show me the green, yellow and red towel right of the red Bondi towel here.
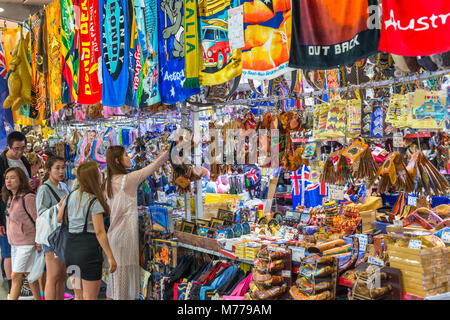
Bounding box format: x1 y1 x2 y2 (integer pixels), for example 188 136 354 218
60 0 79 104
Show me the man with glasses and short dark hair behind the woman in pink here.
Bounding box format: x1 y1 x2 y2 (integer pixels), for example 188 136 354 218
0 131 35 296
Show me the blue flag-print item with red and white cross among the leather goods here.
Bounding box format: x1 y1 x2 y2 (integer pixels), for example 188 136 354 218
291 165 326 210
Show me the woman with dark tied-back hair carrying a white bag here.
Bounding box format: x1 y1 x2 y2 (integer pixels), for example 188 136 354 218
36 155 71 300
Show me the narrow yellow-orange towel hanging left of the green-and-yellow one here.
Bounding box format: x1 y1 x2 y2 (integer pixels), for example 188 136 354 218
45 1 64 112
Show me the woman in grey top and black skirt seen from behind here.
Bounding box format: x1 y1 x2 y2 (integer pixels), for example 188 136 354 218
57 162 117 300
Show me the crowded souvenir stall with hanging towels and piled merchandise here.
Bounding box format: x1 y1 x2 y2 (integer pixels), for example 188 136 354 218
0 0 450 300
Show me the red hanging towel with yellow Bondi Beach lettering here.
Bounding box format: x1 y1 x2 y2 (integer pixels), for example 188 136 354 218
76 0 102 104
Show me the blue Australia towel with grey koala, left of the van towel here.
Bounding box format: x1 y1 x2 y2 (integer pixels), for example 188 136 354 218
158 0 200 104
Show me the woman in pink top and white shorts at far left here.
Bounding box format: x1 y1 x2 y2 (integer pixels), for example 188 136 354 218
2 168 41 300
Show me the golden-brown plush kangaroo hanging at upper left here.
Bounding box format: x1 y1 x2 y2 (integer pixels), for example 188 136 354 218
3 30 31 111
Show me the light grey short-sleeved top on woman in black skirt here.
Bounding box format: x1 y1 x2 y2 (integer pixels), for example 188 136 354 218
64 189 105 233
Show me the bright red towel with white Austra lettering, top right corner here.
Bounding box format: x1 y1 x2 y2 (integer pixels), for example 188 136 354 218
379 0 450 56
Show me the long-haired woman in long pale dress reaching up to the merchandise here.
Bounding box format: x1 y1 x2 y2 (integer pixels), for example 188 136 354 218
106 146 169 300
